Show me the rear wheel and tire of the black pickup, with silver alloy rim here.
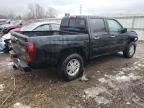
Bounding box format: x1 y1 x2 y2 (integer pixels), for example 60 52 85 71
58 53 83 81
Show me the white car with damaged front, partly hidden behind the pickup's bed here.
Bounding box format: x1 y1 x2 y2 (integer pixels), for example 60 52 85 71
0 22 60 52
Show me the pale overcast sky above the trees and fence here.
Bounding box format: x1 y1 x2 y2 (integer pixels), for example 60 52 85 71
0 0 144 16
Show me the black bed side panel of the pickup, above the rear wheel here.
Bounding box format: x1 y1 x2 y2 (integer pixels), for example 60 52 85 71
29 34 89 68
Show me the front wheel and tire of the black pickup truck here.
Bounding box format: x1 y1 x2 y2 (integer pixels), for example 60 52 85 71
123 42 136 58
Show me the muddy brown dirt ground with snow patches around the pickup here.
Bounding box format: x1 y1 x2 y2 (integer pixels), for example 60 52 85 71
0 43 144 108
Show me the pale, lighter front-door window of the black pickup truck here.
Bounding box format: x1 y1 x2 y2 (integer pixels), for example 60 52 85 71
107 19 122 32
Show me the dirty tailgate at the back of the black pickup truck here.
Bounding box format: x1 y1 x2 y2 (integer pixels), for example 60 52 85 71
11 31 28 61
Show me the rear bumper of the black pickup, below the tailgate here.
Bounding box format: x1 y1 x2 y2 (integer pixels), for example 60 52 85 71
10 50 32 72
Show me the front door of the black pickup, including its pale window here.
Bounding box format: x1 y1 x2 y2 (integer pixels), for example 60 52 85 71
107 19 128 51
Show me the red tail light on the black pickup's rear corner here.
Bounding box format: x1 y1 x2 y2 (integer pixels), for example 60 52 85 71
25 42 35 62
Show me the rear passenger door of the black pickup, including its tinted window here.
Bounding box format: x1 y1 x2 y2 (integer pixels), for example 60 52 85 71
89 18 111 57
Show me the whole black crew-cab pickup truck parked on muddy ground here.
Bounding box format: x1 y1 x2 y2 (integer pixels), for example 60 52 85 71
10 16 138 80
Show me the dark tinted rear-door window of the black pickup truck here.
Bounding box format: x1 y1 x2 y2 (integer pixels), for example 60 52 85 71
90 18 106 34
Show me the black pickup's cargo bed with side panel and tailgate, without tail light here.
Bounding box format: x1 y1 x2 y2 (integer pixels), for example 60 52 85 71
11 31 89 68
